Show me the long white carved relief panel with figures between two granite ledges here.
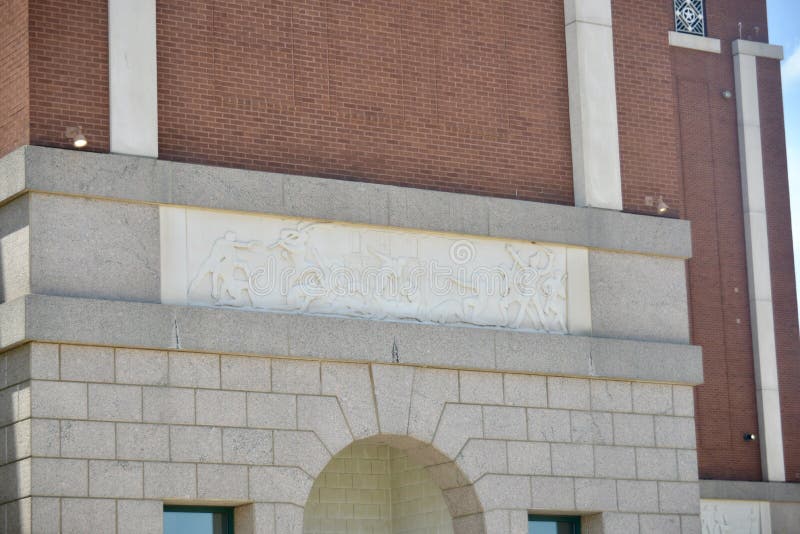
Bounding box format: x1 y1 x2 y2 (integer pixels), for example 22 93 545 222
161 207 589 333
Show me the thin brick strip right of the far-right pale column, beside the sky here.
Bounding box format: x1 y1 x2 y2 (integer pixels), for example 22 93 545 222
758 59 800 482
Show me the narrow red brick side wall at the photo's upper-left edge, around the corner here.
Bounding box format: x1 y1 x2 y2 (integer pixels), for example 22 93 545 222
0 0 29 156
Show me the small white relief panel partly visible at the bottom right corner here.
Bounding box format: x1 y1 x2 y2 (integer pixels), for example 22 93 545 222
700 499 772 534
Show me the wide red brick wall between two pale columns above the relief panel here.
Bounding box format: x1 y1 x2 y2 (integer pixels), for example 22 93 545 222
157 0 573 204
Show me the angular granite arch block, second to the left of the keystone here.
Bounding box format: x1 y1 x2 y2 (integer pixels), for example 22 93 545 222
297 395 353 454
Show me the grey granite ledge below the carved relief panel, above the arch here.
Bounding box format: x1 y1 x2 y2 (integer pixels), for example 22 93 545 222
0 295 703 384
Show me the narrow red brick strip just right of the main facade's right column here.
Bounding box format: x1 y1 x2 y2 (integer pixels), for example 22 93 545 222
612 0 683 217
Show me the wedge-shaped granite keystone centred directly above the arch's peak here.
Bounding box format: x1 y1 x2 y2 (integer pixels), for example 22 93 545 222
372 364 414 436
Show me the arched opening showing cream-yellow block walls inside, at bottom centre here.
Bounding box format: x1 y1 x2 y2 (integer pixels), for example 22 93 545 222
303 436 483 534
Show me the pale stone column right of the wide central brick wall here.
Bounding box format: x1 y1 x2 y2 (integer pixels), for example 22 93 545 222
564 0 622 214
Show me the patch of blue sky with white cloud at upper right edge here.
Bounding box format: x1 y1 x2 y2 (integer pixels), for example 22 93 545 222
767 0 800 302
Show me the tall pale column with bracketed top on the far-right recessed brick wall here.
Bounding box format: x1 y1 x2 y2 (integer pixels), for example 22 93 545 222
733 40 786 481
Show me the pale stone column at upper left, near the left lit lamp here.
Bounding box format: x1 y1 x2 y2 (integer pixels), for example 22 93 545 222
108 0 158 158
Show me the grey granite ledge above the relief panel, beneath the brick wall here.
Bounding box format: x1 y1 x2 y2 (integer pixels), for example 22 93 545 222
0 146 691 259
